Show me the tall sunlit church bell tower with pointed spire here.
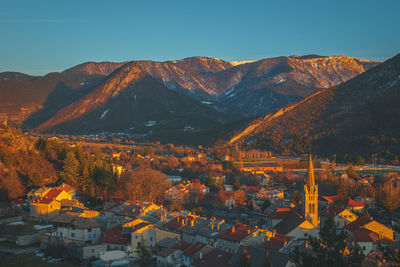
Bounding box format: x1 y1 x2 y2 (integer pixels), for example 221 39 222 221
303 154 319 227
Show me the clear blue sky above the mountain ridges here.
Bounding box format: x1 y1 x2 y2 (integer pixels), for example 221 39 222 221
0 0 400 74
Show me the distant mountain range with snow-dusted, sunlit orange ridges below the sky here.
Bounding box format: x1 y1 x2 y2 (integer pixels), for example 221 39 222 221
0 55 380 144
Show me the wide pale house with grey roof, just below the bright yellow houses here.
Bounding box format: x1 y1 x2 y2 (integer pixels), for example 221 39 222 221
52 214 101 244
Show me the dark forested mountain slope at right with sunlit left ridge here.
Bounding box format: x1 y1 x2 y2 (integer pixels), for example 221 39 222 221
228 54 400 159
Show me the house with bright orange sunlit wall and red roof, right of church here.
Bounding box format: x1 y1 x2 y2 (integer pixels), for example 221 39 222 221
344 216 394 240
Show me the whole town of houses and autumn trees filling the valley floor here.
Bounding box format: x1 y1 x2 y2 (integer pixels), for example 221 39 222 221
0 127 400 267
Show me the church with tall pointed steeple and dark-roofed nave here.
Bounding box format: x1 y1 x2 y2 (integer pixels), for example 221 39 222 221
272 155 320 239
